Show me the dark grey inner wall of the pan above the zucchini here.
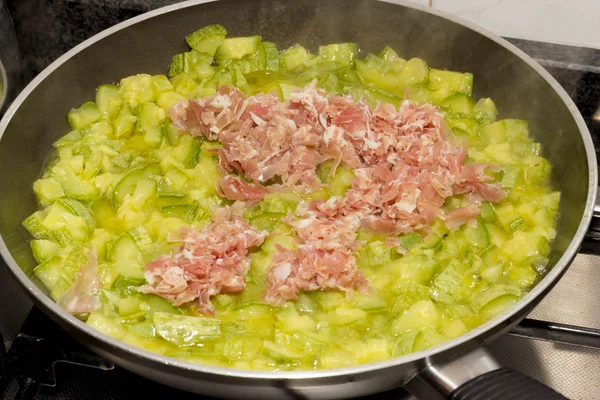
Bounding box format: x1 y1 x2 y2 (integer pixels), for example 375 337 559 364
0 0 589 366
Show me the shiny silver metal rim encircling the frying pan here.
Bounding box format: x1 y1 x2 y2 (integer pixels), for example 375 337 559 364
0 0 598 381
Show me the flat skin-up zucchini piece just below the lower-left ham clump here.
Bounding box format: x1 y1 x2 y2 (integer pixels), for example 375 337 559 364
152 312 221 346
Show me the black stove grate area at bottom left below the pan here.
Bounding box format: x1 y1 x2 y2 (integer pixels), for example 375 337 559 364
0 307 221 400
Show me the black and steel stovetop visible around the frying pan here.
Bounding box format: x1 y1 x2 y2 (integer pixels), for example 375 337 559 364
0 0 600 400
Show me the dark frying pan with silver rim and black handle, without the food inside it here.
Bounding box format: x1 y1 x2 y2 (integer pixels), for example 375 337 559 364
0 0 597 400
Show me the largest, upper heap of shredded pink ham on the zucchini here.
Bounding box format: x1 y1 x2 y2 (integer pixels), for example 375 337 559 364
170 85 504 216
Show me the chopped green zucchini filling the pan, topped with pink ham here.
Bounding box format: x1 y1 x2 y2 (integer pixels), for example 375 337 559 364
23 25 560 371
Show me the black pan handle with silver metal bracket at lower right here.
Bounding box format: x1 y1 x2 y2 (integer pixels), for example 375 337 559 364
406 346 566 400
